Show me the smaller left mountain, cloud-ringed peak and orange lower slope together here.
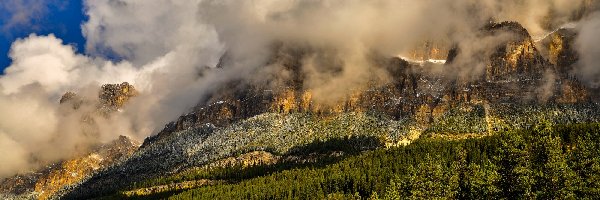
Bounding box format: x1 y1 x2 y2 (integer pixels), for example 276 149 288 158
0 83 140 199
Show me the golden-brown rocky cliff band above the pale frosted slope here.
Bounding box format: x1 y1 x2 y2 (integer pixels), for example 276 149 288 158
145 22 589 147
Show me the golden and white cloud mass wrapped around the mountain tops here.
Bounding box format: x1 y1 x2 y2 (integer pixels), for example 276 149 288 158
0 0 600 177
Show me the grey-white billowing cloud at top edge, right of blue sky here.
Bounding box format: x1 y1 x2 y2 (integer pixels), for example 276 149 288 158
83 0 219 65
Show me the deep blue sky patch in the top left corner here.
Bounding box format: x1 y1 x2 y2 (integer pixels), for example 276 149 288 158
0 0 86 73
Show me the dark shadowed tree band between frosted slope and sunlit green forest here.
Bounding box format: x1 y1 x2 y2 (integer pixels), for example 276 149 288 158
126 135 385 190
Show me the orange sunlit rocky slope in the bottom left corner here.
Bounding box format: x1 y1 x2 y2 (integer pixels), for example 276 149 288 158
0 136 139 199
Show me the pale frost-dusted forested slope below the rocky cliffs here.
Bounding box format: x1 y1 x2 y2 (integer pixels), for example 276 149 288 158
64 113 410 199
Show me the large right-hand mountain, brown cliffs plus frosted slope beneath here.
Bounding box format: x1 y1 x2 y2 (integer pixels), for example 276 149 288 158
55 22 600 199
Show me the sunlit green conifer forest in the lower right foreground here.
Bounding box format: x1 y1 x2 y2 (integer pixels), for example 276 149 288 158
165 124 600 199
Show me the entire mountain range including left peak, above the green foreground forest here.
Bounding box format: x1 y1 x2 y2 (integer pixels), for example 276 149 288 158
0 19 600 199
